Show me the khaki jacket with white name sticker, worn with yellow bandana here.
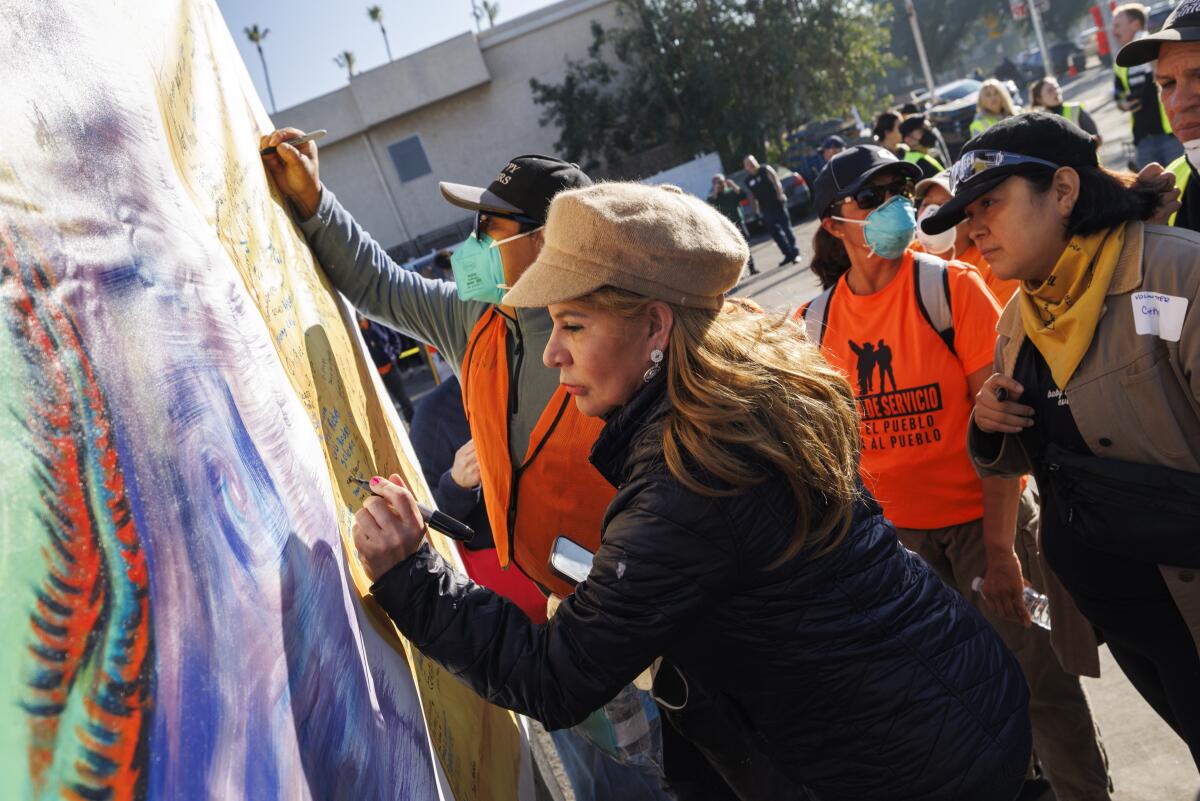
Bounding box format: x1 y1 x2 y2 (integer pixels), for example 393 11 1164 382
968 222 1200 676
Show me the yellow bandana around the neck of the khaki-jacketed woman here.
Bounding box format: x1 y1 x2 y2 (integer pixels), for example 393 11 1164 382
1021 225 1124 389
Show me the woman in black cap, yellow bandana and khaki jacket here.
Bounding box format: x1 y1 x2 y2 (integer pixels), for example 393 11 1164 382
923 114 1200 765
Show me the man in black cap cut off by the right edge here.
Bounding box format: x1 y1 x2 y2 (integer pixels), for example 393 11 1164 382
1116 0 1200 231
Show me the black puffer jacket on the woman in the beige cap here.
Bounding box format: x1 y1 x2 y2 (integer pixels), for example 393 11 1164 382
372 379 1030 801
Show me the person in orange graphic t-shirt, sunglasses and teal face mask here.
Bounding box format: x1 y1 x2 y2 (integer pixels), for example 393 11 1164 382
799 145 1109 800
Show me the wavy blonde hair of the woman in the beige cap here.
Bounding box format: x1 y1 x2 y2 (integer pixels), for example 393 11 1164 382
577 287 860 567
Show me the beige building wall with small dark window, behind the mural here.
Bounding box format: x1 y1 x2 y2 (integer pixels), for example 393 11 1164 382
272 0 617 255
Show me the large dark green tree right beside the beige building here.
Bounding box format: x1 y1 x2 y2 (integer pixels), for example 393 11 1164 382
529 0 890 168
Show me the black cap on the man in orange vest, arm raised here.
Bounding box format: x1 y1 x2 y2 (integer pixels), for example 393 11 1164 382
438 156 592 223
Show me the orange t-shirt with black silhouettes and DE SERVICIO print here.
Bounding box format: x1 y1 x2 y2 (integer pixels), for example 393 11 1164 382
822 252 1000 529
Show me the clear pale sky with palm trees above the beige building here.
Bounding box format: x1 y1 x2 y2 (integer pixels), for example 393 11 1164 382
217 0 553 110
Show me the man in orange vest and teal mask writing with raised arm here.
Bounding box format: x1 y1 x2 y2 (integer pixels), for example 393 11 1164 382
259 128 667 801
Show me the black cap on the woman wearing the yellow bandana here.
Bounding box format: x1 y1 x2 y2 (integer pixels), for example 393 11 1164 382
920 113 1099 234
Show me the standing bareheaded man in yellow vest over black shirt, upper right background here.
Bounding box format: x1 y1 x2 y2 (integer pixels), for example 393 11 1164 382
1112 2 1188 169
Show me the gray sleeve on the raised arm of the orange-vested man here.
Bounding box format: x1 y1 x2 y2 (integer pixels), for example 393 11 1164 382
300 188 487 373
